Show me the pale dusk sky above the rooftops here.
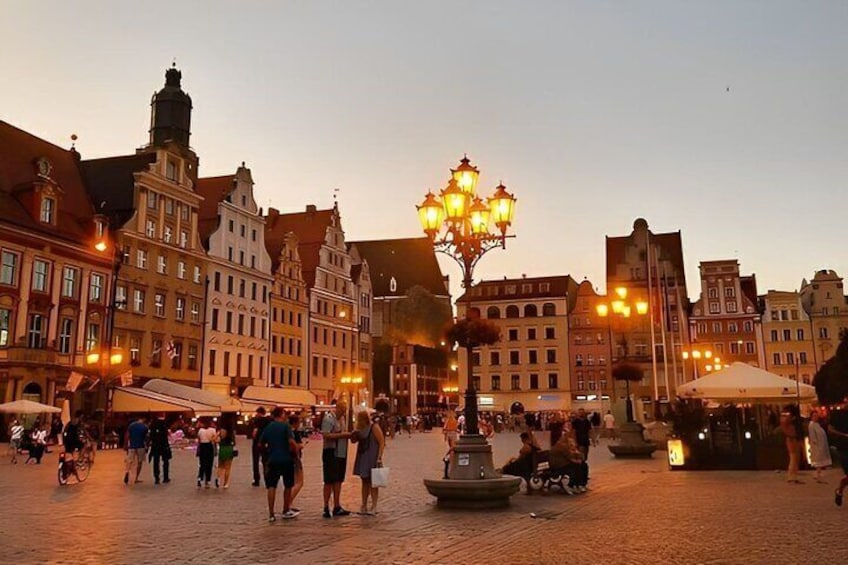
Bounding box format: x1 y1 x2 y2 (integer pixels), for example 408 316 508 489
0 0 848 299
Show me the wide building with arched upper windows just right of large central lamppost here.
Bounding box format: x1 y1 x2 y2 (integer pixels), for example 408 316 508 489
457 275 577 412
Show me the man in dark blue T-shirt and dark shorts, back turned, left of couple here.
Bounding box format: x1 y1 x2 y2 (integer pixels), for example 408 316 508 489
259 406 299 522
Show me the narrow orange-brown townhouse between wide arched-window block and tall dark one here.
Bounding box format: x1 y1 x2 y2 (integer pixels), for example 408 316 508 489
568 280 615 412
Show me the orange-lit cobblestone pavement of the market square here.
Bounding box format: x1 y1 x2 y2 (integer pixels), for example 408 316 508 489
0 433 848 564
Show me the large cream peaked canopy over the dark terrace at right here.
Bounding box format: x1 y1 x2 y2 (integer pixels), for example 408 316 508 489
677 362 816 403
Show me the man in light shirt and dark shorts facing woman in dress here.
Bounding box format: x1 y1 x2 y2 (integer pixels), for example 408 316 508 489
321 401 351 518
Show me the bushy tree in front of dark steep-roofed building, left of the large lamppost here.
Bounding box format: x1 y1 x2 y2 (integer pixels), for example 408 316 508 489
386 285 451 347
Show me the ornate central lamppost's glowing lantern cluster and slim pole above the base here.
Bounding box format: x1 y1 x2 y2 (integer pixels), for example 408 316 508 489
417 156 516 435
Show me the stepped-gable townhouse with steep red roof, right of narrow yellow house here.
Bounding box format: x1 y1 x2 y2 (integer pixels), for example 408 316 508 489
265 205 361 403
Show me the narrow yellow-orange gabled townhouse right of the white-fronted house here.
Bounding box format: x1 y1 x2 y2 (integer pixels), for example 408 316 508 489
270 232 308 394
